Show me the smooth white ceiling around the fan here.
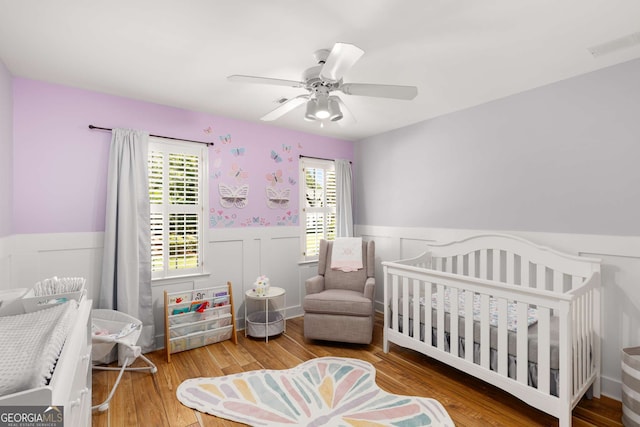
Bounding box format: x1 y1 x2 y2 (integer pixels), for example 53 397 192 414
0 0 640 140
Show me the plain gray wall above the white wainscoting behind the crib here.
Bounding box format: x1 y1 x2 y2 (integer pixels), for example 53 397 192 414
354 60 640 235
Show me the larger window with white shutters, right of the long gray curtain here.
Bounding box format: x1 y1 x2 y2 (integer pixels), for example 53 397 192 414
149 138 208 279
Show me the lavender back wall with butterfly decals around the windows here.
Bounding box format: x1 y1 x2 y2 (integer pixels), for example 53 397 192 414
13 78 353 234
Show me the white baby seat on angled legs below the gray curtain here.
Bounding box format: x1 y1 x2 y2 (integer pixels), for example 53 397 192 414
91 309 158 412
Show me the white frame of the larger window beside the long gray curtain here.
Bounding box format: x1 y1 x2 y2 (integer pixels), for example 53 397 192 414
147 137 209 281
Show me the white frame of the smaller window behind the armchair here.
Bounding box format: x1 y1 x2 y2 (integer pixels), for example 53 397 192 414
298 156 337 262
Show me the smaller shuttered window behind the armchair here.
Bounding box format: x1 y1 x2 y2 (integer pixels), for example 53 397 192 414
300 157 336 260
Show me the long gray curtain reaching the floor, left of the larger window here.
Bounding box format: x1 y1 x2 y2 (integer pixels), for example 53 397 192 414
98 129 155 352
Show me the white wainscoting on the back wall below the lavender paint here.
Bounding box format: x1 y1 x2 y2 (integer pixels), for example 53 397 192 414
0 227 315 356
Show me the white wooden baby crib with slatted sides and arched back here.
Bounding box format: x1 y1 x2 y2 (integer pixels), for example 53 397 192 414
382 235 600 427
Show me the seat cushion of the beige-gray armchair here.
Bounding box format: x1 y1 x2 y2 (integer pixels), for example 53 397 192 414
302 289 373 316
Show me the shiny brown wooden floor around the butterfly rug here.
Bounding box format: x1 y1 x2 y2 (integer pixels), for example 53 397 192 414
92 316 622 427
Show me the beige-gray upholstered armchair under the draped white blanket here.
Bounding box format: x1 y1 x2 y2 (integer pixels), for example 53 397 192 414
302 240 375 344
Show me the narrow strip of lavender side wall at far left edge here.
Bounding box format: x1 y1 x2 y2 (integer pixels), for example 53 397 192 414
0 60 13 237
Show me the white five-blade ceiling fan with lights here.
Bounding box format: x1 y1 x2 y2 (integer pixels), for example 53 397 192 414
227 43 418 122
